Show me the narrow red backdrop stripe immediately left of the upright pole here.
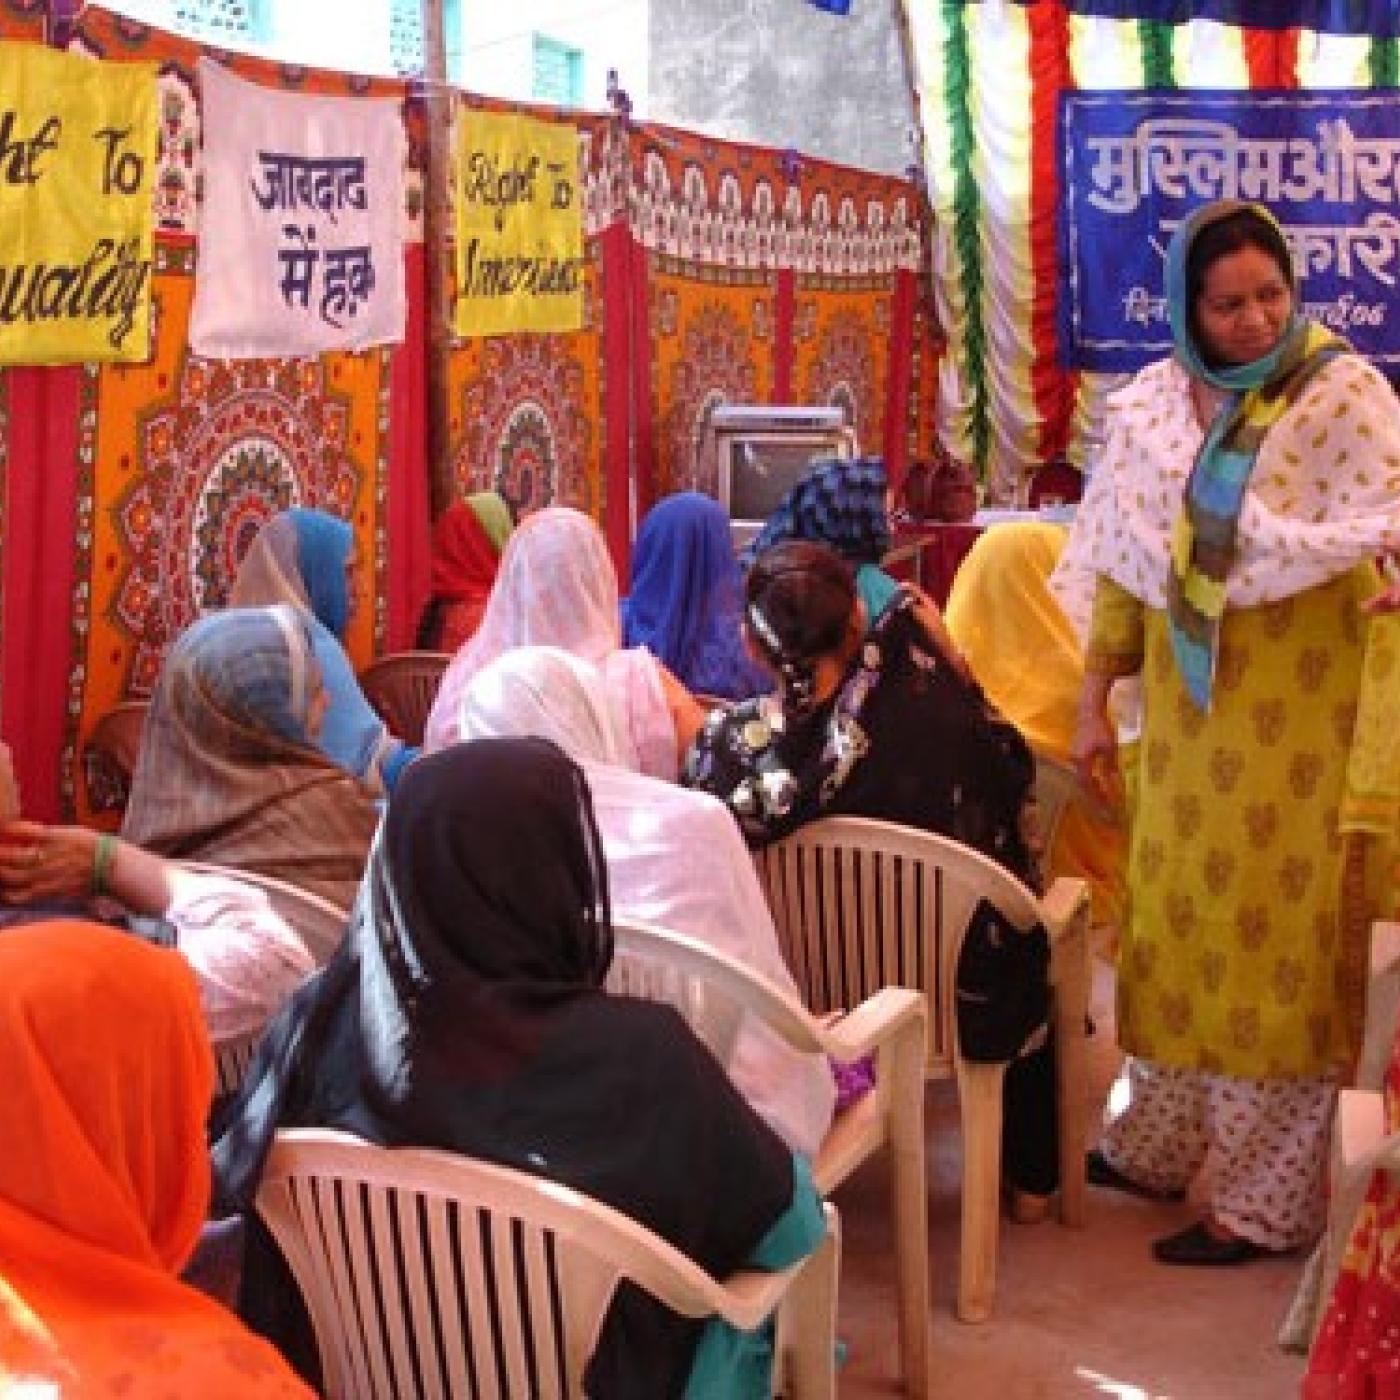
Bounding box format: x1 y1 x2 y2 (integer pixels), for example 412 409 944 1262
386 244 431 651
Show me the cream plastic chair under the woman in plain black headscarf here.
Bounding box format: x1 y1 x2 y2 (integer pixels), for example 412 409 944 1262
258 1128 840 1400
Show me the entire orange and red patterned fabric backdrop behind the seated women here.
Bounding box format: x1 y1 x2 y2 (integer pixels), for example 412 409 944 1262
0 10 938 818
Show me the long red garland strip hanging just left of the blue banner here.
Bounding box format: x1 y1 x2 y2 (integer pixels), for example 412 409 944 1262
1022 4 1075 462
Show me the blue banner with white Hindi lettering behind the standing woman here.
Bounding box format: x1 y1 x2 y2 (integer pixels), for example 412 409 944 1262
1060 90 1400 371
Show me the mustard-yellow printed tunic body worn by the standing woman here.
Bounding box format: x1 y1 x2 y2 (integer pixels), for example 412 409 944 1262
1119 566 1393 1079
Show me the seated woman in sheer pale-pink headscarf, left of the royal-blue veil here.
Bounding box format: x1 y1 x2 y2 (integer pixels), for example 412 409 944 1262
423 505 701 780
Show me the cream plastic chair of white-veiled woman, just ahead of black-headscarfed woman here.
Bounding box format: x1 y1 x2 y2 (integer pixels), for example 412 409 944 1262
608 920 930 1400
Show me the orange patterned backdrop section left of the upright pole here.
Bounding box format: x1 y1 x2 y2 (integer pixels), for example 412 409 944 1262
4 8 427 815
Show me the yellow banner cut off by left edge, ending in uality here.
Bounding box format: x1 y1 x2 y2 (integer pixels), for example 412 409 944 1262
0 42 157 364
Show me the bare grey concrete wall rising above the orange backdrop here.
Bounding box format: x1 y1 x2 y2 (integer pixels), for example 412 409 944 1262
646 0 914 175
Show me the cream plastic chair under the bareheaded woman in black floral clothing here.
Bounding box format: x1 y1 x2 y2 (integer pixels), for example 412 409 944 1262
757 816 1089 1322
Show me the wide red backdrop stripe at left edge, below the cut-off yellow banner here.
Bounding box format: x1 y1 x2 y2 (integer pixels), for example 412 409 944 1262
0 365 83 822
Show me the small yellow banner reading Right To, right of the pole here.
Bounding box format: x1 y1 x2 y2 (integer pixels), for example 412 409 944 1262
452 111 584 336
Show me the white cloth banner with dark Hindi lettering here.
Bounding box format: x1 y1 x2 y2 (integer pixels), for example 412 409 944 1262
189 59 405 360
